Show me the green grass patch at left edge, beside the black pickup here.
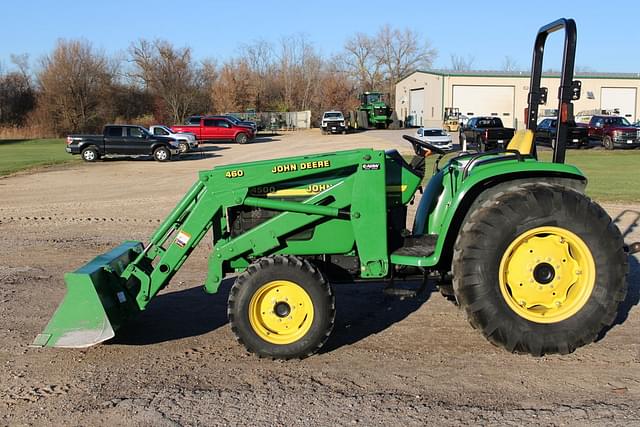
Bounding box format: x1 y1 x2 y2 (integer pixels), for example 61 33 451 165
0 139 78 176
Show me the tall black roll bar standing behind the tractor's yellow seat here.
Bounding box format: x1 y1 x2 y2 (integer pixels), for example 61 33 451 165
527 18 581 163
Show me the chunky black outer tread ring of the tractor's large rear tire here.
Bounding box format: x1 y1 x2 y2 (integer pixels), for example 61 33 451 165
452 183 628 356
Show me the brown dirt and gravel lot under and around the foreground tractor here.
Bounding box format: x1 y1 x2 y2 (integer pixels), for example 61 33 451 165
0 131 640 426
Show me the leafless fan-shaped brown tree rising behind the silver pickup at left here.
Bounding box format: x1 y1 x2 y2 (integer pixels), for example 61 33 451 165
129 39 199 123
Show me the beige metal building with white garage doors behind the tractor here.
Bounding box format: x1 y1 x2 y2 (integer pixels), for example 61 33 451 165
395 71 640 128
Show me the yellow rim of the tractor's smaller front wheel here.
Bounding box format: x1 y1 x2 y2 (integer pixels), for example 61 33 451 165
249 280 313 345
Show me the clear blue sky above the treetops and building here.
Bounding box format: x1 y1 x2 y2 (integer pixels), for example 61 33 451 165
0 0 640 73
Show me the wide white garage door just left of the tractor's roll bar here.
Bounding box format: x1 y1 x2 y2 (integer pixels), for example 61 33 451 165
452 85 515 127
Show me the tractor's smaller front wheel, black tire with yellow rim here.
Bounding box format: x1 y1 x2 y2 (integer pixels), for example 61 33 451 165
227 256 336 359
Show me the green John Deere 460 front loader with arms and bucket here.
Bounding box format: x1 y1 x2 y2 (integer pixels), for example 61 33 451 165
38 149 400 346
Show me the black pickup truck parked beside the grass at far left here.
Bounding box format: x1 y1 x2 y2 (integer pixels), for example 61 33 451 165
65 125 180 162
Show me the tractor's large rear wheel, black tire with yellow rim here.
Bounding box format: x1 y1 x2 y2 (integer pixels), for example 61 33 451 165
453 183 628 356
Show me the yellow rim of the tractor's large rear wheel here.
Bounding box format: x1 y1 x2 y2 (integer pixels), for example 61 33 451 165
499 227 596 323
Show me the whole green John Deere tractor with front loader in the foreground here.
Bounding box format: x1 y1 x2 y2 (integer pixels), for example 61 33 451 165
34 19 638 359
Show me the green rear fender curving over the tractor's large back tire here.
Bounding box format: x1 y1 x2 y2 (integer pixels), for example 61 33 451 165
413 162 586 271
